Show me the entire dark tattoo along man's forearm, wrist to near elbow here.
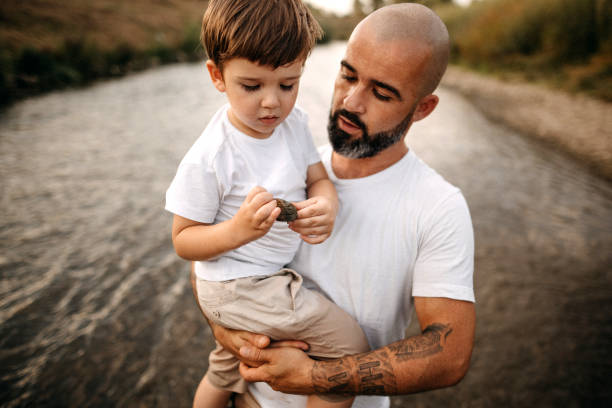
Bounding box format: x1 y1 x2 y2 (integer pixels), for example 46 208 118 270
312 323 452 395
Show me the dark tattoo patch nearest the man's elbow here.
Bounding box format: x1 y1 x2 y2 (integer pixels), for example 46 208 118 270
389 323 453 361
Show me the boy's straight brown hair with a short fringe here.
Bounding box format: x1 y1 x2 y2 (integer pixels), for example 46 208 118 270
201 0 322 71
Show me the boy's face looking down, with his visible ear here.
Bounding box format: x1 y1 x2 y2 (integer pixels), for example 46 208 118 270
206 58 304 139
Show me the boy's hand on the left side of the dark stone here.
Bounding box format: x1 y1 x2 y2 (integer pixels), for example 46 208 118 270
232 186 280 244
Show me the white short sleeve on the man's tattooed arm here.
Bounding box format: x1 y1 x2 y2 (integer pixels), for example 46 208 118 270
412 191 475 302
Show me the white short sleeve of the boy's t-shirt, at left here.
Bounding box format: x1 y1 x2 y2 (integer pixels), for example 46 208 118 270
166 161 221 224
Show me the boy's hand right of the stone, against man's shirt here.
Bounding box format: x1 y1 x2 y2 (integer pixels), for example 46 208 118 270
289 196 338 244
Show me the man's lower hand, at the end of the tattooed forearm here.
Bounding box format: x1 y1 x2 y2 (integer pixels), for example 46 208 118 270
240 343 315 394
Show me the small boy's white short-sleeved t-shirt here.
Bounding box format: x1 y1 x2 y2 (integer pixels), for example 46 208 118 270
166 105 321 281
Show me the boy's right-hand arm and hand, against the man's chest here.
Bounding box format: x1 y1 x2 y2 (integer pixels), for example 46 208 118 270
289 162 338 244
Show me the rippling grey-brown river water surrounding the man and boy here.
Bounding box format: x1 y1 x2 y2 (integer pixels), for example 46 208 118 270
0 44 612 407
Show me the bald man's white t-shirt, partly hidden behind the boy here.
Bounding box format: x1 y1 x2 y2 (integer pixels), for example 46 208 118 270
250 146 474 408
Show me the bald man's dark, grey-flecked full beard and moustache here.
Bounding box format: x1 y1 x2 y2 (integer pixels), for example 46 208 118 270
327 105 416 159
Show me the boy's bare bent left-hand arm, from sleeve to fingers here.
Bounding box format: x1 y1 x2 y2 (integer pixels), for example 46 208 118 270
172 187 280 261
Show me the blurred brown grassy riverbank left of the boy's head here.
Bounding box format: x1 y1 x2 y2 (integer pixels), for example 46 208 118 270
0 0 206 107
